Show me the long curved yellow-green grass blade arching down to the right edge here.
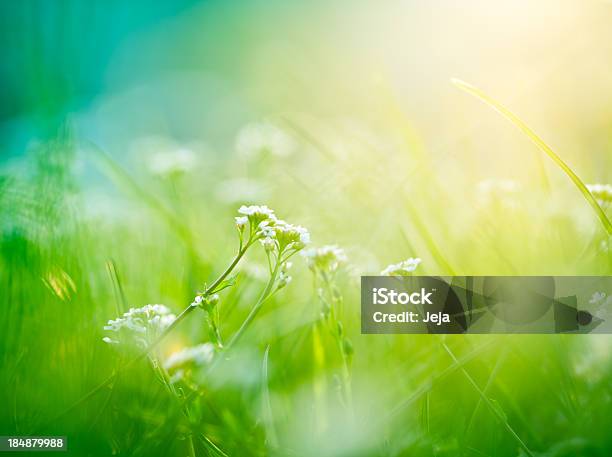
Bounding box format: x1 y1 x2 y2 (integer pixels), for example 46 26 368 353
451 78 612 235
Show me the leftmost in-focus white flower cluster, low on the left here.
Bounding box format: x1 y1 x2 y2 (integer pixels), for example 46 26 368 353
103 305 176 349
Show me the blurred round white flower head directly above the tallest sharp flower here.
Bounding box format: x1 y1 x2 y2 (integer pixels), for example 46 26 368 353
236 122 296 159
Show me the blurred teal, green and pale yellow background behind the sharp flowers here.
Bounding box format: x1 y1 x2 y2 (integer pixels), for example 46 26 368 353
0 0 612 456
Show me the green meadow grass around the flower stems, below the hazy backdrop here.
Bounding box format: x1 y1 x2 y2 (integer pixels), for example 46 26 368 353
0 113 612 457
